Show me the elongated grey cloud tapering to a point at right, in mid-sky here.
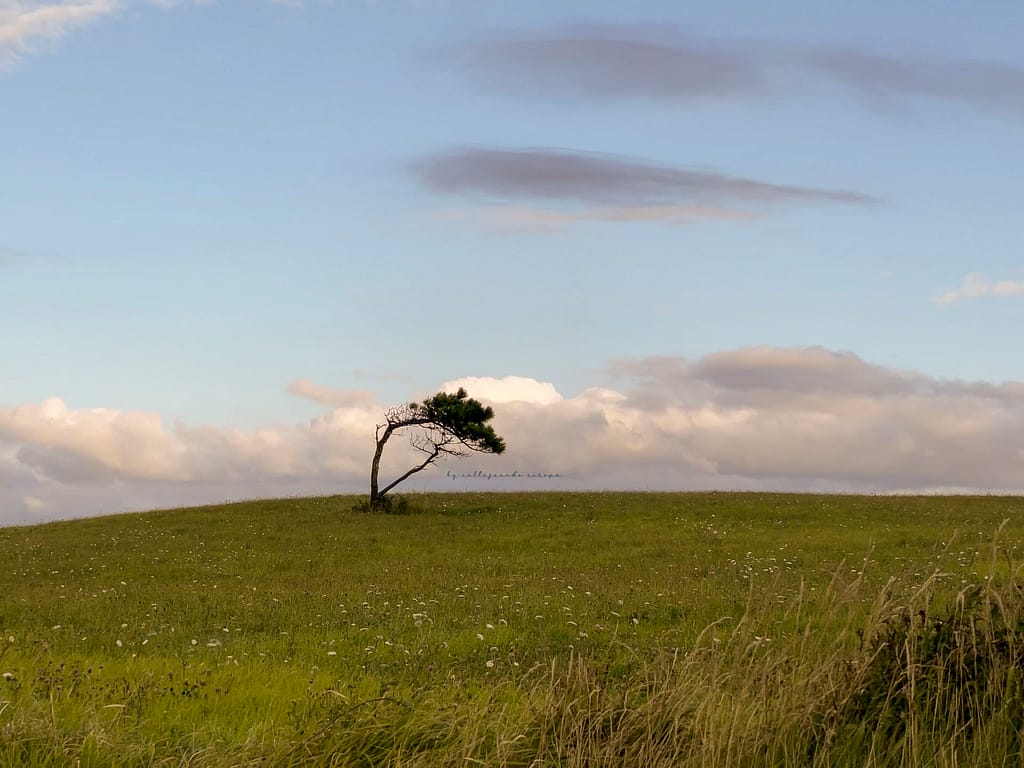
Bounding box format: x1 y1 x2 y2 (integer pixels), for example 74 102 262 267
413 147 874 207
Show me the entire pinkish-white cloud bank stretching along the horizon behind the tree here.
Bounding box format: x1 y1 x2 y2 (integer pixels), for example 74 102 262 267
0 347 1024 523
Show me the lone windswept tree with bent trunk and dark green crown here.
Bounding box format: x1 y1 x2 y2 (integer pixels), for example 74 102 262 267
370 387 505 508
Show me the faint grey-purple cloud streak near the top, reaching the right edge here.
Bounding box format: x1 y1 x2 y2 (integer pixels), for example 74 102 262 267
447 26 1024 117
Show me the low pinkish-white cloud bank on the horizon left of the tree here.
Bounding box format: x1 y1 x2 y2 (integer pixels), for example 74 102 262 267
0 398 380 523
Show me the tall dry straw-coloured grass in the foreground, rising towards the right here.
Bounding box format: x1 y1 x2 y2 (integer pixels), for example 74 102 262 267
251 557 1024 768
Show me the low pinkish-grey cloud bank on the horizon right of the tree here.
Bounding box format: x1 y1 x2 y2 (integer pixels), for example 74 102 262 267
430 358 1024 493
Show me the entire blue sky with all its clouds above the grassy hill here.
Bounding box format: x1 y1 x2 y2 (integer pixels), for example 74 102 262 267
0 0 1024 524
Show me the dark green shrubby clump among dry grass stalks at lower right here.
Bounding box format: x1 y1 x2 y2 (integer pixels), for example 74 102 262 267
812 582 1024 761
